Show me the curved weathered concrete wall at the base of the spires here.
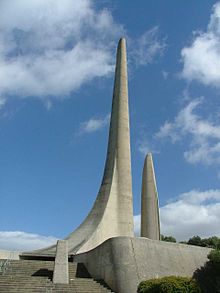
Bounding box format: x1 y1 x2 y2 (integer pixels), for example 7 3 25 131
74 237 210 293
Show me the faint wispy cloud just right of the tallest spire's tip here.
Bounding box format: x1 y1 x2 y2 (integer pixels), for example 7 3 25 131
131 26 166 65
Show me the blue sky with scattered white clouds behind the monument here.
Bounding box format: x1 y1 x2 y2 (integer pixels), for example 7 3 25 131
0 0 220 250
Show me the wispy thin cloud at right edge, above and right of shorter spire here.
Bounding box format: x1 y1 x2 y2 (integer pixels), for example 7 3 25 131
155 98 220 165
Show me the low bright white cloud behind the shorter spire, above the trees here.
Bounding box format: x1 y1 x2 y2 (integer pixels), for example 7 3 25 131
134 189 220 241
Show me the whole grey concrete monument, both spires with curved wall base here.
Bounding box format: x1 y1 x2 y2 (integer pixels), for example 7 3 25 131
0 38 213 293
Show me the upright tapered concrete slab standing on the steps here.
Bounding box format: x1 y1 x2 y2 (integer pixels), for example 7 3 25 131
53 240 69 284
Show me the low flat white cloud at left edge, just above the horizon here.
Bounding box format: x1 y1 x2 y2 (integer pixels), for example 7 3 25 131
0 231 57 251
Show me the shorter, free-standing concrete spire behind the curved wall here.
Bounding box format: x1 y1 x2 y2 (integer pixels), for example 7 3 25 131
141 153 160 240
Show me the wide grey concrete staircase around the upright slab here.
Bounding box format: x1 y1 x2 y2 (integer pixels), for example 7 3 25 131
0 260 112 293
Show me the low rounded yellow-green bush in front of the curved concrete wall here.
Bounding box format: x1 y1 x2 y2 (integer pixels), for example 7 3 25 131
137 276 201 293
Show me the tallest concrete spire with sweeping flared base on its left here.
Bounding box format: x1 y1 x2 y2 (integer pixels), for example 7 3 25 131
24 38 134 254
